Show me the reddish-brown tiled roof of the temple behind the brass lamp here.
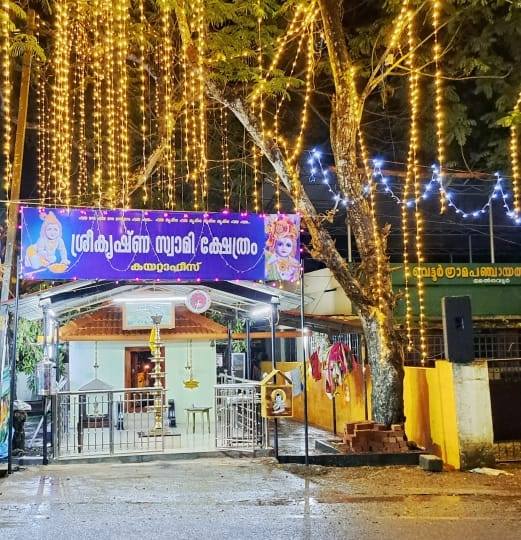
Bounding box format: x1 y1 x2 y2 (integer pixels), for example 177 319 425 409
60 306 227 341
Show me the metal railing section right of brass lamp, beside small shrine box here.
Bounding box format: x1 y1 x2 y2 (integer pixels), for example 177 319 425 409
215 374 268 451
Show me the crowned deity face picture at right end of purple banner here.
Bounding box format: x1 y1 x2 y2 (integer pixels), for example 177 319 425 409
265 215 300 281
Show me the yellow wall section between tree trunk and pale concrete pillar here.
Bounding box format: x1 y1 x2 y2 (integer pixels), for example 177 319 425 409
403 360 460 469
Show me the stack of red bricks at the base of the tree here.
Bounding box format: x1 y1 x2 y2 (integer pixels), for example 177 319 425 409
339 422 408 453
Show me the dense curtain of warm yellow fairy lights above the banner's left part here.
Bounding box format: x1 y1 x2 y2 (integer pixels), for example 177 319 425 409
31 0 207 213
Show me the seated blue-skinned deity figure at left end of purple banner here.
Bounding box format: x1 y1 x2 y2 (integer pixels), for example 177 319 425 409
25 211 70 274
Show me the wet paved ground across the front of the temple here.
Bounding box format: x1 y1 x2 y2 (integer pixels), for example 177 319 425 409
0 459 521 540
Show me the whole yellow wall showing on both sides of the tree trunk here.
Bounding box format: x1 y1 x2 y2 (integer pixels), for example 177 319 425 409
261 360 460 469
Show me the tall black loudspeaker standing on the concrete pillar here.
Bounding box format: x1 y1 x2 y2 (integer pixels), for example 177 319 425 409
441 296 474 364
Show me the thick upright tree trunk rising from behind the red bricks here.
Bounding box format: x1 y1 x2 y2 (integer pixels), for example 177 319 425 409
319 0 404 426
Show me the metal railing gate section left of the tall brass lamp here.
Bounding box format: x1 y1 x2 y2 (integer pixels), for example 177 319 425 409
55 388 165 459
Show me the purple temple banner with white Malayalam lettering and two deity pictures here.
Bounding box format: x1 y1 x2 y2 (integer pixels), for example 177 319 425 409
22 207 300 281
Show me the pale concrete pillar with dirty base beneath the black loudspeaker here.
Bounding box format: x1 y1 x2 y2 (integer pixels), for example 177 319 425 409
452 360 495 470
